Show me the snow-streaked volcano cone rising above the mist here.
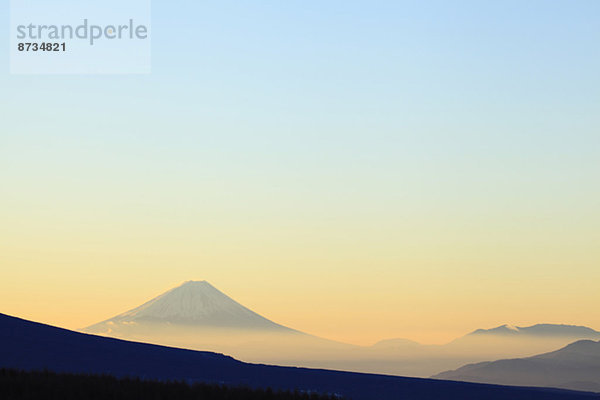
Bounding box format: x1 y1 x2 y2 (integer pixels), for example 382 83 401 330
84 281 295 334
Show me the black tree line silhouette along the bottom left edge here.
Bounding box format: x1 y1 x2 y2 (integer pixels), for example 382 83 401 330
0 369 340 400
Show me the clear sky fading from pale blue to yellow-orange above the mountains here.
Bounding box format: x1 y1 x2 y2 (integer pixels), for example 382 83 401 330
0 0 600 344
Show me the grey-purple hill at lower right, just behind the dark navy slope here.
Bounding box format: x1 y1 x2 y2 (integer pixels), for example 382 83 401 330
434 340 600 392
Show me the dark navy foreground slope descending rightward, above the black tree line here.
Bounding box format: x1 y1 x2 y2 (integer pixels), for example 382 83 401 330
0 314 600 400
